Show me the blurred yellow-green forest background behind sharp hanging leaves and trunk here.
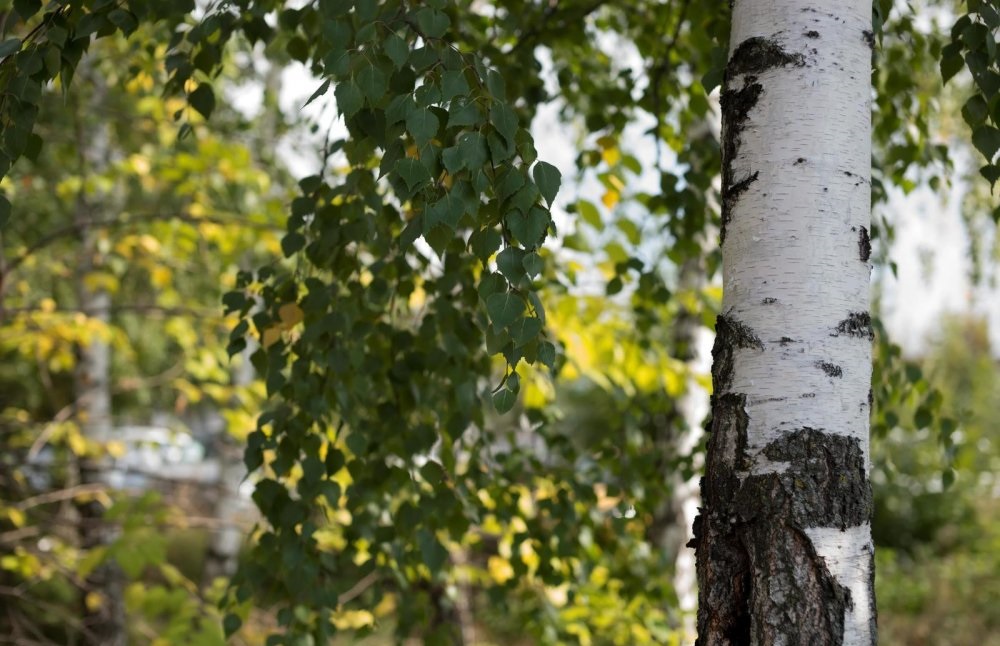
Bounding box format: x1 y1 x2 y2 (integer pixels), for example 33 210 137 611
0 0 1000 645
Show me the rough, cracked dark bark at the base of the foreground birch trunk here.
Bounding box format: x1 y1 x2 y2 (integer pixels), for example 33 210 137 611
691 422 872 646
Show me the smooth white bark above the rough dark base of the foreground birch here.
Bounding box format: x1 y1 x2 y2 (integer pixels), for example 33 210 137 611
722 0 871 471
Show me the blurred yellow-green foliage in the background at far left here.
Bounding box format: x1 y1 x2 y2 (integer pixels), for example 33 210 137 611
0 25 284 643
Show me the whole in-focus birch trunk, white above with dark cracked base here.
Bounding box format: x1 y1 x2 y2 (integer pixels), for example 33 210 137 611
692 0 875 646
